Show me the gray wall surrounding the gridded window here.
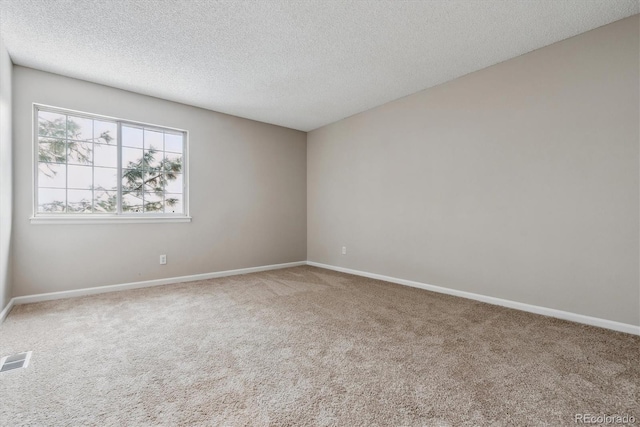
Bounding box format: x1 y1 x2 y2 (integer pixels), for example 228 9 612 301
12 67 306 296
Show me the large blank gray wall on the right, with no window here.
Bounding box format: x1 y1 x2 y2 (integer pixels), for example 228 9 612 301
307 15 640 325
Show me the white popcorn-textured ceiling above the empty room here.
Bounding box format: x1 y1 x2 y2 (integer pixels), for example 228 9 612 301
0 0 640 131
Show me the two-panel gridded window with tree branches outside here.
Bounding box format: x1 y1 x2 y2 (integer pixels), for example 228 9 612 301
33 105 188 222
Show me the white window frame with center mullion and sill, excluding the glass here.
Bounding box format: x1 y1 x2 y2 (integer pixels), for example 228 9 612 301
30 103 191 224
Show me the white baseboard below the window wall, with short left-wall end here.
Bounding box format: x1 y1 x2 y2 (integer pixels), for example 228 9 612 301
6 261 307 310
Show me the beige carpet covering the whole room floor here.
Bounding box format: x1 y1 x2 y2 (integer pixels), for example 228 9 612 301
0 267 640 426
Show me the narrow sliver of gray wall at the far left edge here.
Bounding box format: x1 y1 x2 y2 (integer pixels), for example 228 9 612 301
0 38 13 310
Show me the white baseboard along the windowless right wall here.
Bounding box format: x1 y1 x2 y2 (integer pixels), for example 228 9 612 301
307 261 640 335
